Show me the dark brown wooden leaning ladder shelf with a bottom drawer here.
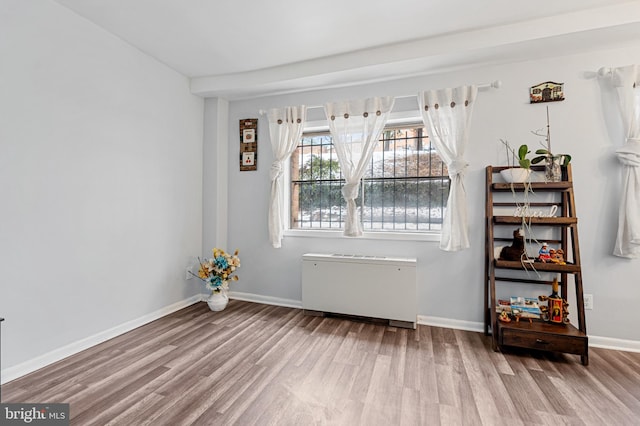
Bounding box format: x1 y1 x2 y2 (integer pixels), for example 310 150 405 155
484 166 589 365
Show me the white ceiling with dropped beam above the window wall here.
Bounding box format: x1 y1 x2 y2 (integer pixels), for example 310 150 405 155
55 0 640 99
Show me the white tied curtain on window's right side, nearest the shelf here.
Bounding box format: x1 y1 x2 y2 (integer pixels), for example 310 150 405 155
418 86 478 251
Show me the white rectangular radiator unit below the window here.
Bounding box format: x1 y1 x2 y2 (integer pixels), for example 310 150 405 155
302 253 417 328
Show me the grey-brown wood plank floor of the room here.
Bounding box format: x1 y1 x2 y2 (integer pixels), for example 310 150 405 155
2 300 640 426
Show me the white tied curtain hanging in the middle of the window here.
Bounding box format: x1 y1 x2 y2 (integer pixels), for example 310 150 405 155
324 97 394 237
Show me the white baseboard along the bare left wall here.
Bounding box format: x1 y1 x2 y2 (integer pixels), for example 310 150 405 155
0 295 202 384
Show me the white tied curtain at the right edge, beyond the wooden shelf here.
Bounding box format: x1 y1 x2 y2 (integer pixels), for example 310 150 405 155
612 65 640 259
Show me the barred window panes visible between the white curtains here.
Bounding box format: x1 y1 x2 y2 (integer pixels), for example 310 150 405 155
290 124 450 232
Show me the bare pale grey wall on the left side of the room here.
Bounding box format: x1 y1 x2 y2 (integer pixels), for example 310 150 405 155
0 0 204 372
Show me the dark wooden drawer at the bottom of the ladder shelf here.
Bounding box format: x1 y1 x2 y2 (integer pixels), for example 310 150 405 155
500 328 587 355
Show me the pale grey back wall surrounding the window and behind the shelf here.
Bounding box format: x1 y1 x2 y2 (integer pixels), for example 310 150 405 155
219 42 640 342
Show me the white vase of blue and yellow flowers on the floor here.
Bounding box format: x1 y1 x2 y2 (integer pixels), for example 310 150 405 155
191 248 240 311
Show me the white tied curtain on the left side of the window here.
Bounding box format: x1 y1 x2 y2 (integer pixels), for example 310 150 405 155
267 105 307 248
